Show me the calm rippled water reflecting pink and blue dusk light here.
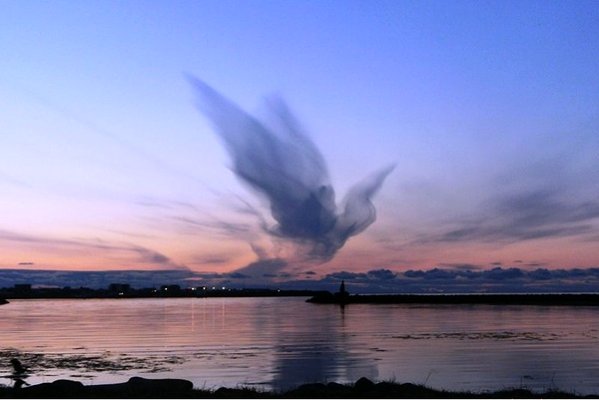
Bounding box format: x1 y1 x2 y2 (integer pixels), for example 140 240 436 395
0 298 599 394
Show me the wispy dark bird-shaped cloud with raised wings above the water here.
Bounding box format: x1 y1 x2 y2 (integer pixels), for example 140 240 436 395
190 78 393 261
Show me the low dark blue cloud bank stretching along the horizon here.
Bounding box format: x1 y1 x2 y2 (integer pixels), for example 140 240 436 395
0 265 599 293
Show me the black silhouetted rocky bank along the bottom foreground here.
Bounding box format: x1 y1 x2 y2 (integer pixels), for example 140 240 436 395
0 377 599 399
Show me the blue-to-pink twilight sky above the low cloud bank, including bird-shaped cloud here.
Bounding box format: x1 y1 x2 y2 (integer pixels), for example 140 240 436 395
0 0 599 290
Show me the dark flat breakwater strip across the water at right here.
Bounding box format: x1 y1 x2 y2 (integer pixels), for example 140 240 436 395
306 292 599 306
